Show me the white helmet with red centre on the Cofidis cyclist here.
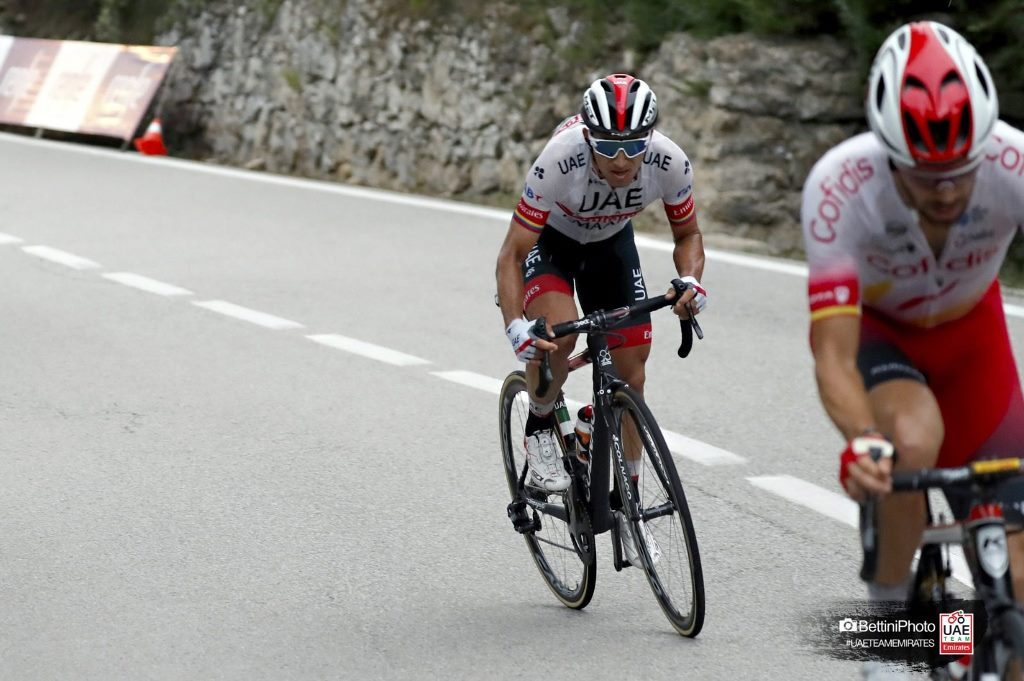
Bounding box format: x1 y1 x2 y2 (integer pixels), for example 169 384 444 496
865 22 999 166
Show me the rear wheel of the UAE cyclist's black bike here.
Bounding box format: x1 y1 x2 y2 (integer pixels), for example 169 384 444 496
499 371 597 610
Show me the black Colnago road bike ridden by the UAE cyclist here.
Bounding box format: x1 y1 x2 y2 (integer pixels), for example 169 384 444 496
499 280 705 637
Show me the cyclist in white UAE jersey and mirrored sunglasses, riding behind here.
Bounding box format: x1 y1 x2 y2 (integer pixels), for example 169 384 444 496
497 74 707 561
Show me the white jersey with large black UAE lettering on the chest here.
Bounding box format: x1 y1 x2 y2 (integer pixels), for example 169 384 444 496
513 116 696 244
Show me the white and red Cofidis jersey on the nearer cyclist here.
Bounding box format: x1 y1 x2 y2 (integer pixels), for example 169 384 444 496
801 122 1024 328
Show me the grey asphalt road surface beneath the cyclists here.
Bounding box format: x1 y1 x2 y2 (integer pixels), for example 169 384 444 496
0 136 1024 681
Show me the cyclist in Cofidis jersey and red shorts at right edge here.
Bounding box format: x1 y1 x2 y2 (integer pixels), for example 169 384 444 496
802 22 1024 600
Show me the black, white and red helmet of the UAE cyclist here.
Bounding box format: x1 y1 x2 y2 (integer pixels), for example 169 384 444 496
581 74 657 138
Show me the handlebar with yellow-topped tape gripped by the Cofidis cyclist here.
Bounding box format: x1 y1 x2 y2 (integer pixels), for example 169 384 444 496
860 459 1024 582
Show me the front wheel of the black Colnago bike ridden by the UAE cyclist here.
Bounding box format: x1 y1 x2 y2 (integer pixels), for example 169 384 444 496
612 387 705 638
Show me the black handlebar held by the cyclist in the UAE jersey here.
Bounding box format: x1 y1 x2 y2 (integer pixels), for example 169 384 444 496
534 279 703 397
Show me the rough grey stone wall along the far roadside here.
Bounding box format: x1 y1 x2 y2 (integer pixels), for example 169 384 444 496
159 0 863 253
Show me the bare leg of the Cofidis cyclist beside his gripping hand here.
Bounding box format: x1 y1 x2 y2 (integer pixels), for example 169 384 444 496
868 379 944 587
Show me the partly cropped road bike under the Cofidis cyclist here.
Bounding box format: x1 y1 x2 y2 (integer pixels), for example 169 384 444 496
860 459 1024 681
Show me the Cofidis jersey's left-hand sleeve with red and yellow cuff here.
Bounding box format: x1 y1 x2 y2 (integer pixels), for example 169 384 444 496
800 156 860 322
